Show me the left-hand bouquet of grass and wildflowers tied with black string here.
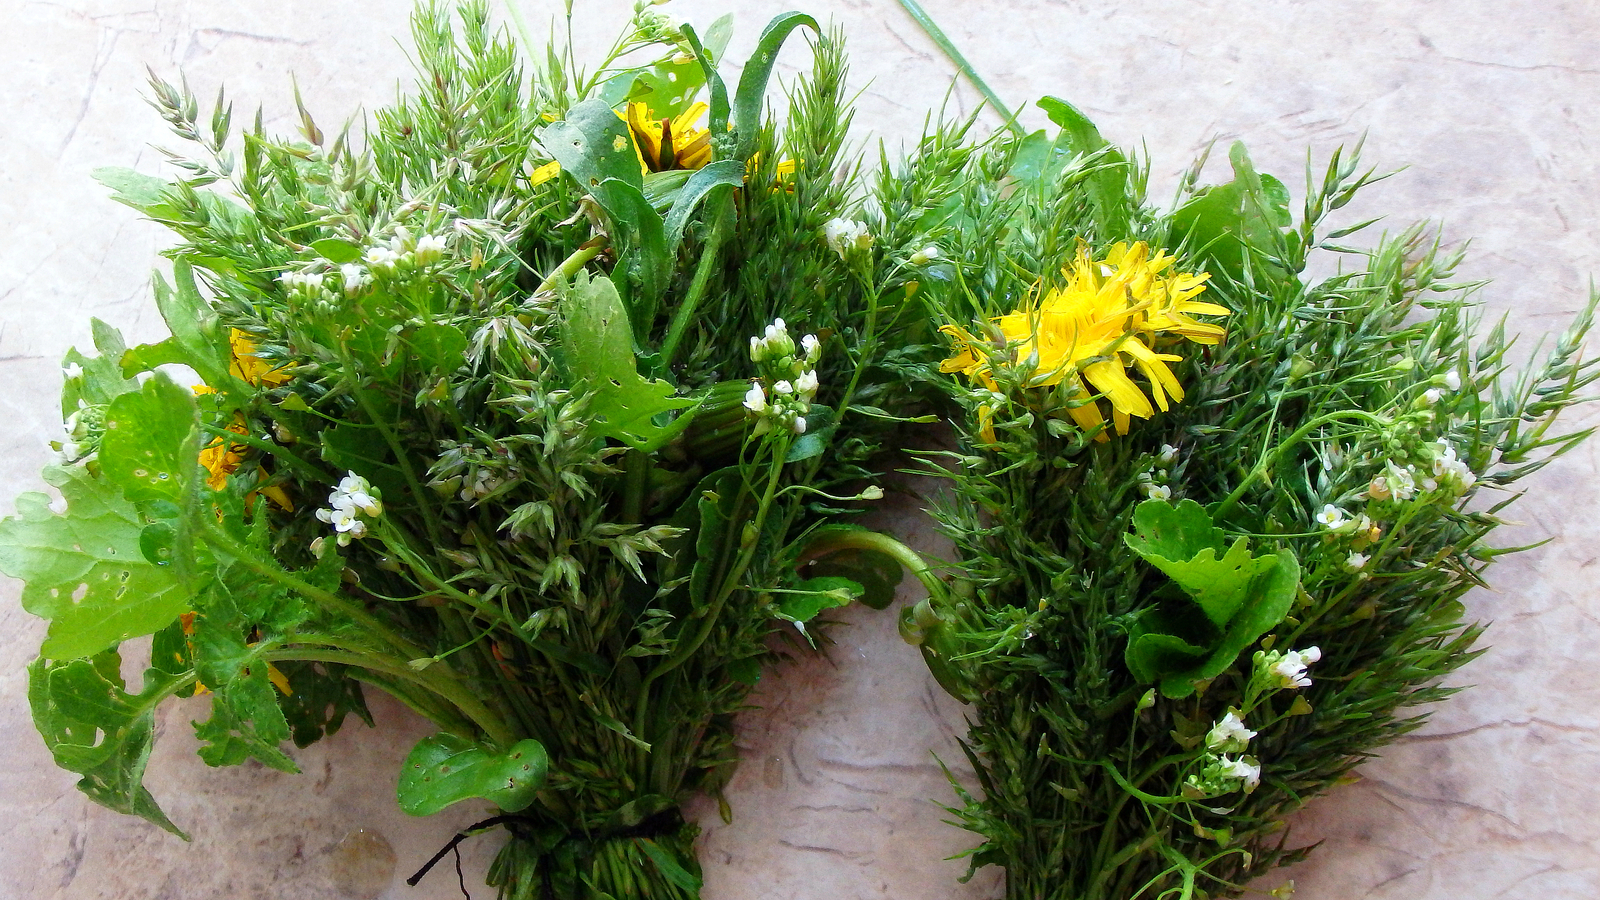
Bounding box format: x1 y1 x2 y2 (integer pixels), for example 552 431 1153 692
0 0 928 898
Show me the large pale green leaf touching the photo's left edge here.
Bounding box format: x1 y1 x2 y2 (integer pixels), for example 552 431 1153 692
0 468 190 660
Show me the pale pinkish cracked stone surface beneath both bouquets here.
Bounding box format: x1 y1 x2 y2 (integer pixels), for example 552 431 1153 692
0 0 1600 900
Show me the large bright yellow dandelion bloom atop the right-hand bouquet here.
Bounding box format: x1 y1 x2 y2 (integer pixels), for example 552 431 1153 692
939 242 1229 440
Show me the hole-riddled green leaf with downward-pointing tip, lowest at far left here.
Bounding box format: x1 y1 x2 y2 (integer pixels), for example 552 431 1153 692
27 650 189 841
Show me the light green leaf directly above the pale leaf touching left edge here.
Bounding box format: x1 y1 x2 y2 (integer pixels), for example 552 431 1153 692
101 372 200 503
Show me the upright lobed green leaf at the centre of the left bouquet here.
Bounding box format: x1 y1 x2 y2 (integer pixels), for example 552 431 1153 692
562 272 696 452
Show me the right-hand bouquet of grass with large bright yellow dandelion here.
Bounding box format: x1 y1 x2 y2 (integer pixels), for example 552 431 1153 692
902 98 1600 900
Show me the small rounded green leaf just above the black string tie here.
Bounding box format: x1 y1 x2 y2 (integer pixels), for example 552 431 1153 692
395 732 549 815
